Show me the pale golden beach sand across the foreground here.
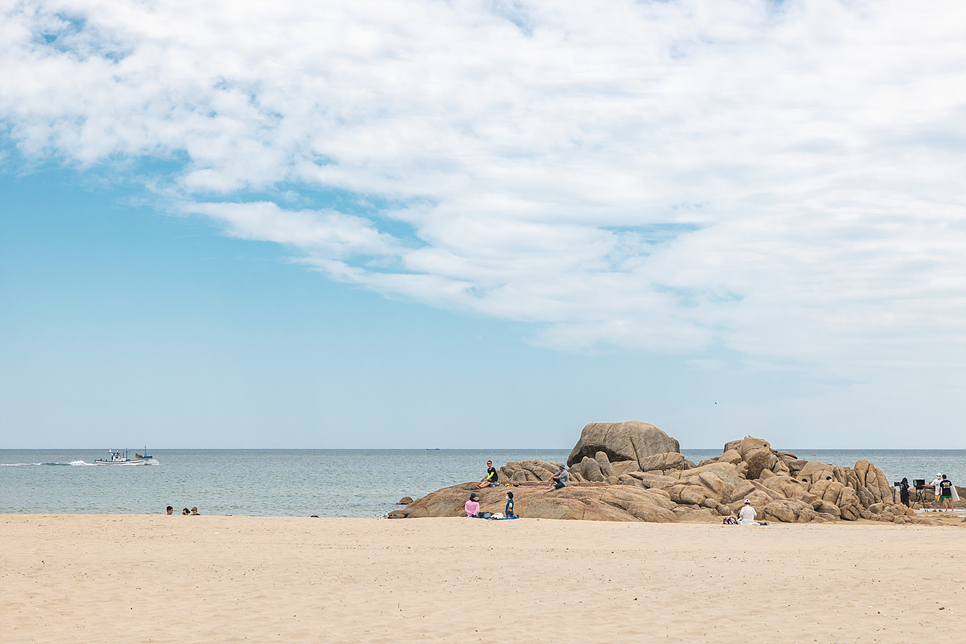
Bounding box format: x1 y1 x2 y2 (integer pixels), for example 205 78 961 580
0 515 966 644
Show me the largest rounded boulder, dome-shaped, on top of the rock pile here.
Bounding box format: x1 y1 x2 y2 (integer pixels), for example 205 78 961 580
567 420 681 469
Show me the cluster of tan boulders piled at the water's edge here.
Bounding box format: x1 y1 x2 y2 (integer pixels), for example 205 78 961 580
390 421 930 523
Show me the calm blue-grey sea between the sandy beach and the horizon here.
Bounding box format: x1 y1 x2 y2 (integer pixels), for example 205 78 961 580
0 448 966 518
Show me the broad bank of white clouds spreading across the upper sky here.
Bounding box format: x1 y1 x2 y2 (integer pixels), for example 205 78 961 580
0 0 966 383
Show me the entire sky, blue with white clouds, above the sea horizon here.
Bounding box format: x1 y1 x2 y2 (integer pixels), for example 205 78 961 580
0 0 966 449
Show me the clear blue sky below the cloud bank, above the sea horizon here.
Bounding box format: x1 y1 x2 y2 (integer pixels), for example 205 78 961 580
0 169 800 448
